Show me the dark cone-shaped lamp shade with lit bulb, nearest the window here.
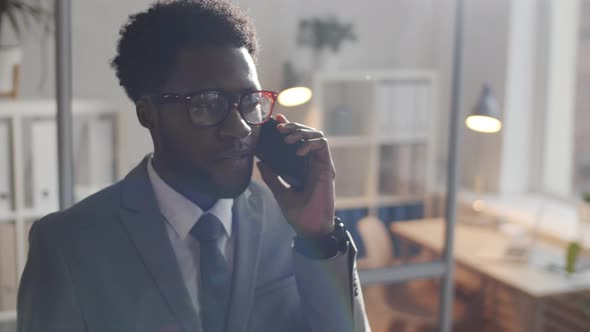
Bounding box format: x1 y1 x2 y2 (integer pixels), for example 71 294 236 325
465 84 502 133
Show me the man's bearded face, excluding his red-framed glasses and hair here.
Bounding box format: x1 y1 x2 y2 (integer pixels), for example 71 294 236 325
146 47 260 198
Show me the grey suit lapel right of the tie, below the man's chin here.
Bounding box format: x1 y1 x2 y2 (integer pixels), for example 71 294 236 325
226 189 265 332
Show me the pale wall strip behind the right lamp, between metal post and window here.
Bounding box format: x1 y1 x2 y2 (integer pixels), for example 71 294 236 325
461 0 511 192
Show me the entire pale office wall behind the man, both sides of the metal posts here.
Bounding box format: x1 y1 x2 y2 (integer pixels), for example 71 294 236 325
11 0 509 189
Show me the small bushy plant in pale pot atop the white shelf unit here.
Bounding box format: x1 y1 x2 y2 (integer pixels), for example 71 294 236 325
297 16 357 70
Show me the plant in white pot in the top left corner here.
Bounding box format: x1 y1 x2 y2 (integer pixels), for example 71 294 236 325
0 0 52 97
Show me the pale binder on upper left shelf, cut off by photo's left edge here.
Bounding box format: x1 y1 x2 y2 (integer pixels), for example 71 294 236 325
0 121 13 215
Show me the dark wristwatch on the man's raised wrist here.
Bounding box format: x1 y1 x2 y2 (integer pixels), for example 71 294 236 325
293 217 349 259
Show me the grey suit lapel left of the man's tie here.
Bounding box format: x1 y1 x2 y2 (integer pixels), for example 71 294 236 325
120 158 201 332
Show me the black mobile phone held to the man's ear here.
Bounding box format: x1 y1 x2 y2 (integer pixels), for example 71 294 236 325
256 118 309 191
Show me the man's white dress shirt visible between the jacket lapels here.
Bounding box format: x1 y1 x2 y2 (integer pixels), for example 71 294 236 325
147 158 235 314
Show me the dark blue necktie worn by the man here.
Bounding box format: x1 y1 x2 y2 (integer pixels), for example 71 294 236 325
190 213 231 332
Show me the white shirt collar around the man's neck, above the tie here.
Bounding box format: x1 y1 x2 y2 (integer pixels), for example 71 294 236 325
147 157 234 240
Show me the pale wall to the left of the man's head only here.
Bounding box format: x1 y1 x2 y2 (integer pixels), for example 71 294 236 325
21 0 157 167
